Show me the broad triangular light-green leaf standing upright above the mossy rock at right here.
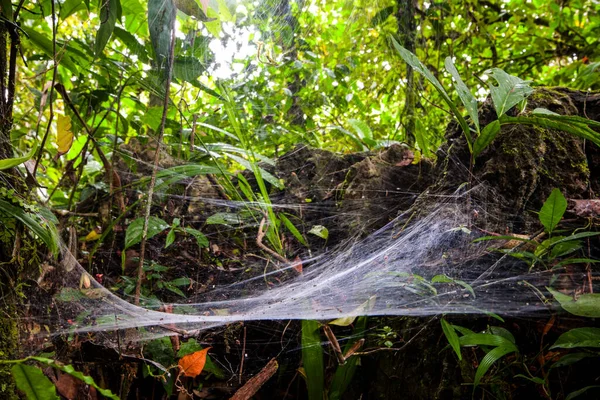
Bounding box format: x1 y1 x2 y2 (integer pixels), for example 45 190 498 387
485 68 533 118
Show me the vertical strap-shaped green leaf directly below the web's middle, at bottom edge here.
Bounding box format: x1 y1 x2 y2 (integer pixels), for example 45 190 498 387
302 320 325 400
